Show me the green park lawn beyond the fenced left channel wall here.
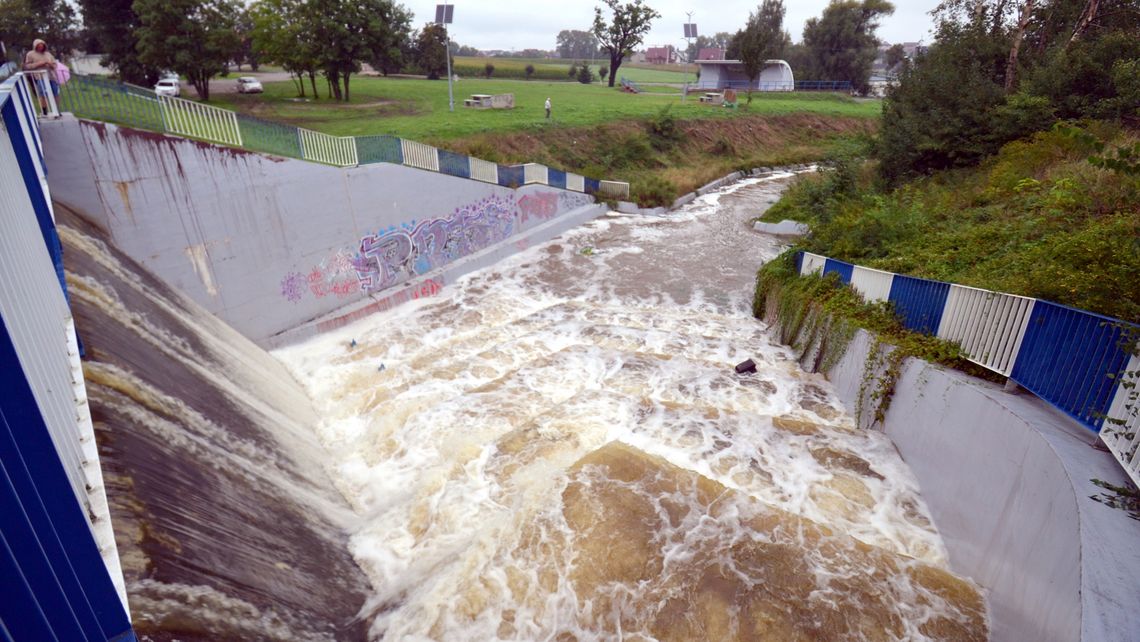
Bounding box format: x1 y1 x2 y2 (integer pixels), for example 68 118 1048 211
211 75 880 143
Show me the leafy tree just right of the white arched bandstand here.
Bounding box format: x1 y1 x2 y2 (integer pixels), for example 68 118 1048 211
804 0 895 94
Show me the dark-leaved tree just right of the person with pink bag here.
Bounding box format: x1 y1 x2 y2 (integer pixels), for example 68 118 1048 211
79 0 161 87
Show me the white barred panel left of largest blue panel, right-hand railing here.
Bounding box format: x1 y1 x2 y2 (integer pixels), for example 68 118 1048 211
937 284 1034 376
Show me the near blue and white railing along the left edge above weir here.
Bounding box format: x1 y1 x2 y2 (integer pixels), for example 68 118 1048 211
0 75 137 642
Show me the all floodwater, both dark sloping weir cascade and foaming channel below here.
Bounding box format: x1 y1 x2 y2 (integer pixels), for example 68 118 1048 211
62 177 987 642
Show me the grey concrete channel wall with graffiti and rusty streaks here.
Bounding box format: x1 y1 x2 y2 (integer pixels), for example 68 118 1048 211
42 116 605 346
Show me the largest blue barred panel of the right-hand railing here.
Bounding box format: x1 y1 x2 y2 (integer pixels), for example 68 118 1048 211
1010 300 1134 431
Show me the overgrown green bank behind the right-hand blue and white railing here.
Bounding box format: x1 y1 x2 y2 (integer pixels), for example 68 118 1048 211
764 123 1140 322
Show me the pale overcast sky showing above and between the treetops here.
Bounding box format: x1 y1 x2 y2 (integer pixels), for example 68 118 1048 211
402 0 938 50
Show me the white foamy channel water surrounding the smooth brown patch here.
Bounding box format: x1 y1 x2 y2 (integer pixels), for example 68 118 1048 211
275 176 989 640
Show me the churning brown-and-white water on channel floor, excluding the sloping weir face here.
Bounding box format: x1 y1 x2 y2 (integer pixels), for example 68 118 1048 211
277 177 986 641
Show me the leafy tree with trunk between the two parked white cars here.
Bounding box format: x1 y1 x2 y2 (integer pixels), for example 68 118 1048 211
135 0 239 100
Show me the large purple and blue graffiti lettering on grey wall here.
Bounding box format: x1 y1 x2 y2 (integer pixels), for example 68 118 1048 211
352 196 516 291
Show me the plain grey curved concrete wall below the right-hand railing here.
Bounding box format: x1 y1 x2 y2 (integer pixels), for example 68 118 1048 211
767 317 1140 642
